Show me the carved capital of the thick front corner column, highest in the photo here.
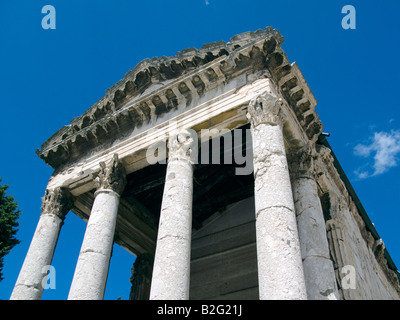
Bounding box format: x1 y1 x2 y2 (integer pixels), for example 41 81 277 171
246 92 286 127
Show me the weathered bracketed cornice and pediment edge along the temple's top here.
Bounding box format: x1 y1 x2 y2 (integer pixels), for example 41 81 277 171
37 27 322 169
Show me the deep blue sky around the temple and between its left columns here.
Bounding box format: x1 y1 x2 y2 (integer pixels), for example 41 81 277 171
0 0 400 299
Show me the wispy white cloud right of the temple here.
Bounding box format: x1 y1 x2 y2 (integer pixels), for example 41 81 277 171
354 130 400 179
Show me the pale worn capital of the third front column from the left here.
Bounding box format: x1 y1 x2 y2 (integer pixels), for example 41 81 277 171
168 129 197 164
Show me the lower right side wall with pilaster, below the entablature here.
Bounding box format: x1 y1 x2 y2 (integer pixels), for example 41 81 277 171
327 191 399 300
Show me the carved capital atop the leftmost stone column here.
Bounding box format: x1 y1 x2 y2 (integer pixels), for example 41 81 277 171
41 187 74 220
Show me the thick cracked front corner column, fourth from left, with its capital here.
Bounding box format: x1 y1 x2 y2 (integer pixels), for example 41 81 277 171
247 92 307 300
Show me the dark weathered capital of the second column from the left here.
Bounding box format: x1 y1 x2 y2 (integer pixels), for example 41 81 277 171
95 153 126 195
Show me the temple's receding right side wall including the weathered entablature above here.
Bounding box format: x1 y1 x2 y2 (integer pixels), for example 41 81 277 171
316 146 400 300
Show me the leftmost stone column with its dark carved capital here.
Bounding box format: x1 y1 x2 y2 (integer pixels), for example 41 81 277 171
10 188 73 300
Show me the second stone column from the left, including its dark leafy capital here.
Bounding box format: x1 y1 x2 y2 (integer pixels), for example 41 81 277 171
68 154 126 300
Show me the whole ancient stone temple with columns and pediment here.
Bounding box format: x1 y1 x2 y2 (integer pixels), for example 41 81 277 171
11 28 400 300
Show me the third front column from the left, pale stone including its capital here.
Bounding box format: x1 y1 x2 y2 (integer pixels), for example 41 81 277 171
150 130 194 300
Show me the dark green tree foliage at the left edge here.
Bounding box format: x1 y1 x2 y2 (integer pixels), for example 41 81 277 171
0 178 21 281
